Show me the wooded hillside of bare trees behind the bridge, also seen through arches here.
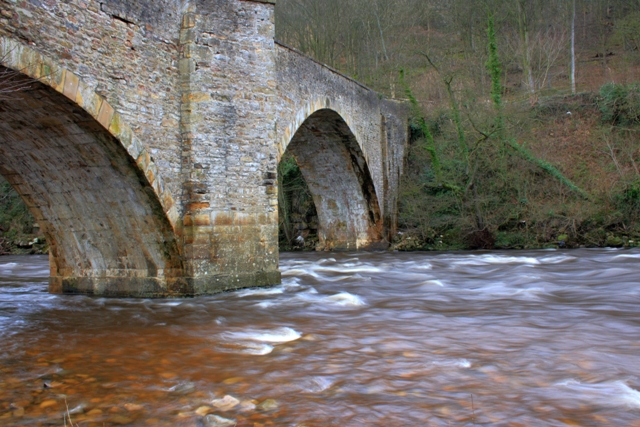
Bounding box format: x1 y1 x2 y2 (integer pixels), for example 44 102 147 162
0 0 640 254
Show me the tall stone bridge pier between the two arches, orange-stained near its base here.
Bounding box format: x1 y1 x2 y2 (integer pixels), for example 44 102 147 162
180 0 280 292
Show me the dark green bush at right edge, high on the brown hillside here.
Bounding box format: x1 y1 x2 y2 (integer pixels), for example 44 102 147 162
598 83 640 126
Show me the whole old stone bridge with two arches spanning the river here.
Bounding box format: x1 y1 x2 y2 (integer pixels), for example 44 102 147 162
0 0 407 297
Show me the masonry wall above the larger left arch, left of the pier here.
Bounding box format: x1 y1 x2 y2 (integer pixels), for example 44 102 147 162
0 0 184 210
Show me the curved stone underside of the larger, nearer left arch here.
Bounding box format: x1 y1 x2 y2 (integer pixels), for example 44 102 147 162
0 67 188 297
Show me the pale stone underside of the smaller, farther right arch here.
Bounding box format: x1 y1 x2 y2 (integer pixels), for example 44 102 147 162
287 109 384 250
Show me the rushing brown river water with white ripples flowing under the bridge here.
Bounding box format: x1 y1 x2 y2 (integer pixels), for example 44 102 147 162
0 250 640 427
